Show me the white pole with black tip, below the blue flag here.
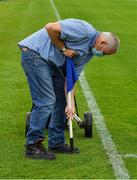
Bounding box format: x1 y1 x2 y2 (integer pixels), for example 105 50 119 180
68 91 74 151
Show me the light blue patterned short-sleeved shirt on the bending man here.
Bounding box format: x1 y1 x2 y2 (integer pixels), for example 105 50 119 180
18 19 99 75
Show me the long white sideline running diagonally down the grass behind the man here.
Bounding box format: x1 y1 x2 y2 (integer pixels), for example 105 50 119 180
50 0 130 179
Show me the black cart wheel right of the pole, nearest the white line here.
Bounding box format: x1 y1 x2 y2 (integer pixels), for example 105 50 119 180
84 112 92 138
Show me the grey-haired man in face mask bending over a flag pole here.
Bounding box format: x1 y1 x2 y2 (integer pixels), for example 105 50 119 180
19 19 119 160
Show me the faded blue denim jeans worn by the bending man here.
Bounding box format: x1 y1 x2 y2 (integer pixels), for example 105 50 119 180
22 50 66 147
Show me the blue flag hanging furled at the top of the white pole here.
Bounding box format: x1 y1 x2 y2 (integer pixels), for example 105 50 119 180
66 57 78 93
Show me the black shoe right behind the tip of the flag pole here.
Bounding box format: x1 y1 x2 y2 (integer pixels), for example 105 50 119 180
49 144 80 154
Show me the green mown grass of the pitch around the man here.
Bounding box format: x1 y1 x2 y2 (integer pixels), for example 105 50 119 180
0 0 137 179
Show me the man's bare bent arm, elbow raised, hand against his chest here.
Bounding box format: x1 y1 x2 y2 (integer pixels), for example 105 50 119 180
45 22 77 58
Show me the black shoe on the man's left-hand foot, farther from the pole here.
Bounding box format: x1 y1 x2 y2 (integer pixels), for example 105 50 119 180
25 142 56 160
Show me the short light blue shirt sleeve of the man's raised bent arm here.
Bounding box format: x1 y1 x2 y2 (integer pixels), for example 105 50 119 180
59 19 91 43
